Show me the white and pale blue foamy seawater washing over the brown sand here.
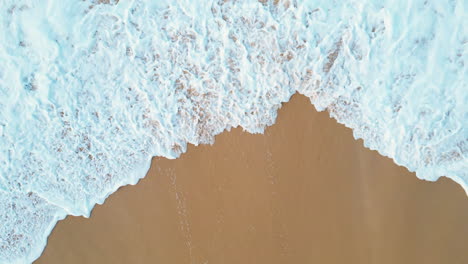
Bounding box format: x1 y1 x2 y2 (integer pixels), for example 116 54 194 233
0 0 468 263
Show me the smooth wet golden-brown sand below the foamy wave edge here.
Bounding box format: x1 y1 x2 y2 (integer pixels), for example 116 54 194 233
36 95 468 264
